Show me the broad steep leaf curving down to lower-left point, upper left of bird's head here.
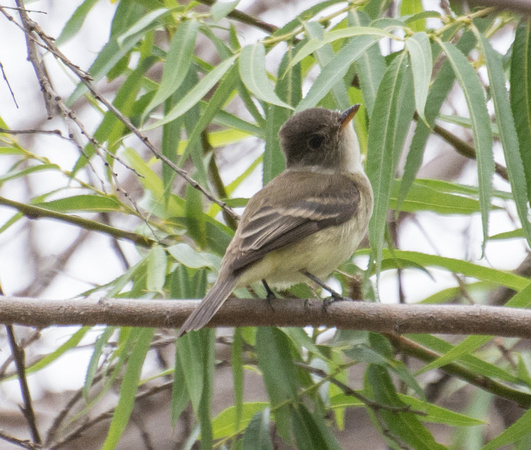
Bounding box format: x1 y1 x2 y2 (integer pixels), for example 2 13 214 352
144 20 199 116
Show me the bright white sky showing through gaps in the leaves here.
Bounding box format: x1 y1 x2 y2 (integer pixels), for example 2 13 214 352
0 0 525 401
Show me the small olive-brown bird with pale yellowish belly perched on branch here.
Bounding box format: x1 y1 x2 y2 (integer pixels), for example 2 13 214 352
177 104 373 337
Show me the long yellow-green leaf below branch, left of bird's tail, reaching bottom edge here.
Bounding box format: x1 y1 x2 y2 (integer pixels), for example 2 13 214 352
102 328 155 450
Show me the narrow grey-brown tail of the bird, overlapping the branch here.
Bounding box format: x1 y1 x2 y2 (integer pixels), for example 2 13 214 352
177 276 238 337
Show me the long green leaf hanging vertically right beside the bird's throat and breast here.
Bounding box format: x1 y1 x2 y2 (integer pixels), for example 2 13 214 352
366 52 415 271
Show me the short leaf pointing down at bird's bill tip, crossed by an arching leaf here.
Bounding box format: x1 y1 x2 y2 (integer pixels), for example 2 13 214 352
348 10 386 117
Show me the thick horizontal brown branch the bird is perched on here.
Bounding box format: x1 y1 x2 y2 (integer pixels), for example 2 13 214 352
0 297 531 339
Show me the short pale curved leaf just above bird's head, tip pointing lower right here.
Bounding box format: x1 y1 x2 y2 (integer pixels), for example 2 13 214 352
239 43 293 109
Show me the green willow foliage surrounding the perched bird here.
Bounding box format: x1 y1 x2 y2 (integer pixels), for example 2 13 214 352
0 0 531 449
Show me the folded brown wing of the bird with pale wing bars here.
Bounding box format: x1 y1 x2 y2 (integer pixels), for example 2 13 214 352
227 171 360 272
